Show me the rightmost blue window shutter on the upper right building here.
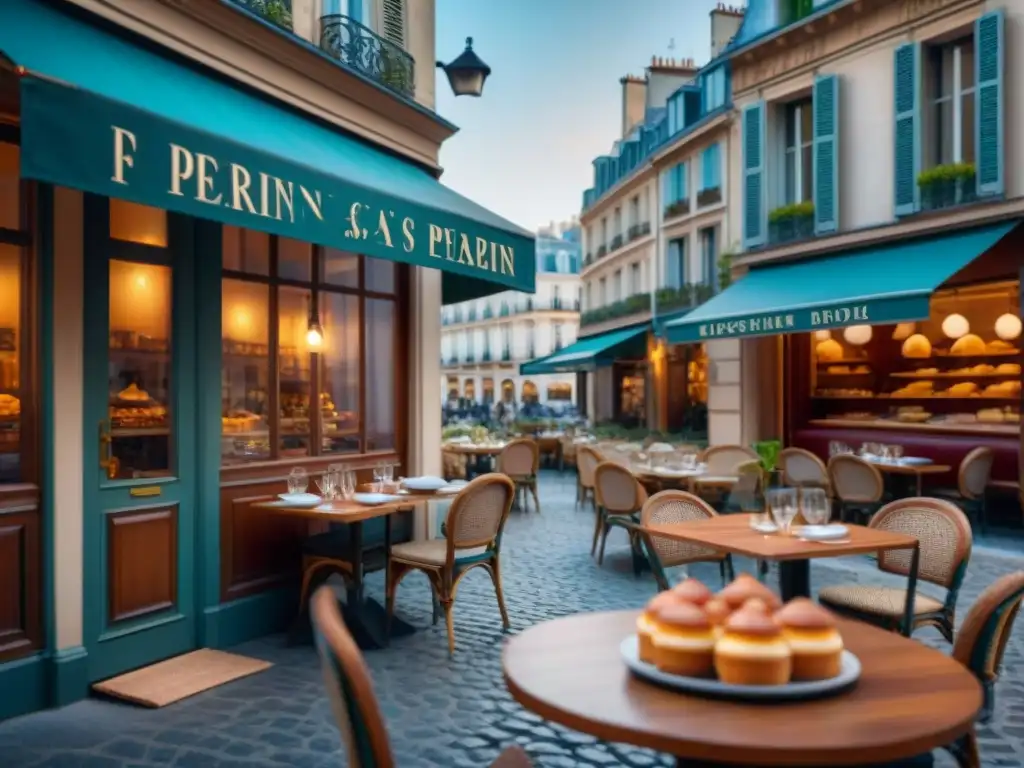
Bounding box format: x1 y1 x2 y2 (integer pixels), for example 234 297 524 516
974 9 1005 196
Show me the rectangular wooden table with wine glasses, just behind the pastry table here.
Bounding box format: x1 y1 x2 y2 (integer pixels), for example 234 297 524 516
641 514 921 634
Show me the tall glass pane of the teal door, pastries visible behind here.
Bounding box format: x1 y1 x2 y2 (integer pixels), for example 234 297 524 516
105 259 171 479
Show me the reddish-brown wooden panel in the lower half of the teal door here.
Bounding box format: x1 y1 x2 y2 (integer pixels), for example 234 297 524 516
106 505 178 624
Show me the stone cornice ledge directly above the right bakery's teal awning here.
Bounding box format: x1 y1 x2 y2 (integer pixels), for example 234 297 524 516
732 198 1024 271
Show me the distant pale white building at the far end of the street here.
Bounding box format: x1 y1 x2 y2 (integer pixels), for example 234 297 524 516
441 221 581 410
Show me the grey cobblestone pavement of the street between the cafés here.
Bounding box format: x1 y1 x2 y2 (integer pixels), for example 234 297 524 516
0 473 1024 768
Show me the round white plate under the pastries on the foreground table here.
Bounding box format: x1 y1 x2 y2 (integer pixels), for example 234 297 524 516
618 635 860 701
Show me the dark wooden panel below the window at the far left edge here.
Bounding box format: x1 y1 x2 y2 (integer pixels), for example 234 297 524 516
0 485 42 663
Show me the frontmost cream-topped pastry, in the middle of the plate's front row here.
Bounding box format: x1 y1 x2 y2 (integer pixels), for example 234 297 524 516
715 606 793 685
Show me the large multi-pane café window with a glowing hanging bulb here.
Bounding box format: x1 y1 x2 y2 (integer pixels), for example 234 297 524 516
221 226 404 465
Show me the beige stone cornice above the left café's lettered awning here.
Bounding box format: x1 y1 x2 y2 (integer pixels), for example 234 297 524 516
70 0 458 173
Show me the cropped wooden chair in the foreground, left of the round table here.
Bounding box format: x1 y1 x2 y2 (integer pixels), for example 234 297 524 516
311 587 532 768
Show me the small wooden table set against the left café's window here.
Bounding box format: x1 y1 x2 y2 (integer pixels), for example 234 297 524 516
260 494 428 650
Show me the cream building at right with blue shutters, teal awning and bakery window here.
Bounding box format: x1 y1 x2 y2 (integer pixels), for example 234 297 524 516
666 0 1024 489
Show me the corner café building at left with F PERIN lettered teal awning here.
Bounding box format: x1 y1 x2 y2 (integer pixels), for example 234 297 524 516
0 0 536 718
